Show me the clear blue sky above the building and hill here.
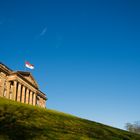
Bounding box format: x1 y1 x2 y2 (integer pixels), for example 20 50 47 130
0 0 140 128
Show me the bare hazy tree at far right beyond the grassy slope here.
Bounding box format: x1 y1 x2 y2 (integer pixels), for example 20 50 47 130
125 121 140 134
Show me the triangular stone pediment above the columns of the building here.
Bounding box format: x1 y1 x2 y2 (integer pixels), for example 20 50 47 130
18 71 38 88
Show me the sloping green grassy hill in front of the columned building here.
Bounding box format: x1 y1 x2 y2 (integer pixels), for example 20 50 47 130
0 98 140 140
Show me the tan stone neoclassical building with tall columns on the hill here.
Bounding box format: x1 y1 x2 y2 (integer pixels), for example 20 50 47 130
0 63 47 108
